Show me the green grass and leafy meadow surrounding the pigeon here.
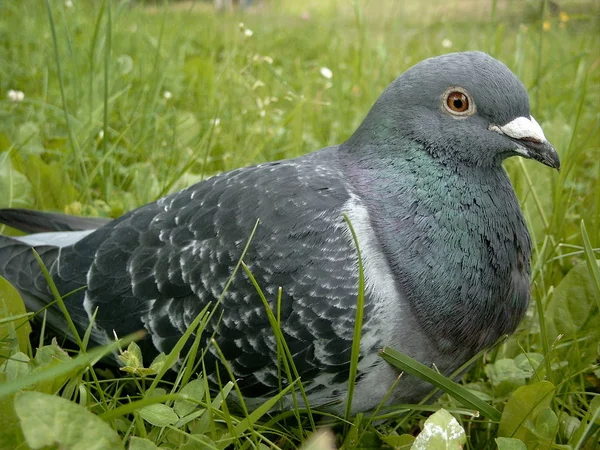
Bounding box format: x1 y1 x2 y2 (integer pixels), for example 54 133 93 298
0 0 600 449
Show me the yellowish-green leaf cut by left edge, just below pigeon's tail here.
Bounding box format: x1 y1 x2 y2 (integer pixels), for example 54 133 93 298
0 276 31 361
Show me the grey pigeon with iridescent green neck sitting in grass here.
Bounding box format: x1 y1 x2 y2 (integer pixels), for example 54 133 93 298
0 52 560 414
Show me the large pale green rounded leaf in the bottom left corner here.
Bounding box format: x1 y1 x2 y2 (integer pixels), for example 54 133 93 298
14 392 123 450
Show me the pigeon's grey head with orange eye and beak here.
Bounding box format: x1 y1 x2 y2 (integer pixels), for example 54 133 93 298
346 52 560 169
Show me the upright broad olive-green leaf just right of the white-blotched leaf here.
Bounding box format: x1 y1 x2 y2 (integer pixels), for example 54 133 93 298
498 381 554 444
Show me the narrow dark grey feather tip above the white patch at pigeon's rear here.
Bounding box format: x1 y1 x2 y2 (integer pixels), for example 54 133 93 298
0 208 110 233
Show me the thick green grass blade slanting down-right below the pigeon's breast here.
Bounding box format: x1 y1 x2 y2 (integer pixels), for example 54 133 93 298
381 347 501 422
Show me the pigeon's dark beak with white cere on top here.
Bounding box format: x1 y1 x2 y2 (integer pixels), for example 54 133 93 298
489 116 560 170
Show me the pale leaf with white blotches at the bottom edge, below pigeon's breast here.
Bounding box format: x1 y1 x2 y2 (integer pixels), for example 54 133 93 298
411 409 467 450
